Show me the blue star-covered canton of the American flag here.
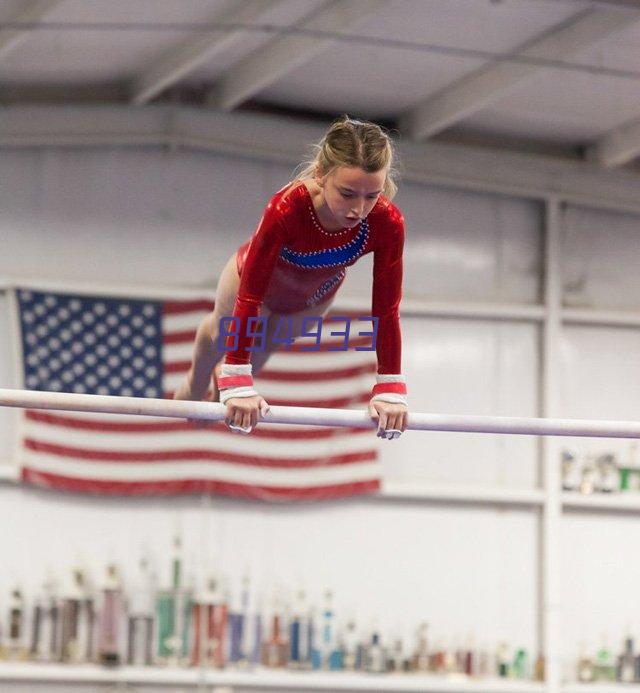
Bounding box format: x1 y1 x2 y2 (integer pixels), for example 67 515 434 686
18 290 163 397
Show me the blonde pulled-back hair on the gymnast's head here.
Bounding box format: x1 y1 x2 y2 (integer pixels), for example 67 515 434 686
294 115 398 200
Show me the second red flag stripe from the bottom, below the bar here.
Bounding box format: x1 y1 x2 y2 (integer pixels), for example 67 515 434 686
23 438 376 469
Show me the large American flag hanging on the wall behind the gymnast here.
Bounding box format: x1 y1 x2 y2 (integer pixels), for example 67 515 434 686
14 288 380 501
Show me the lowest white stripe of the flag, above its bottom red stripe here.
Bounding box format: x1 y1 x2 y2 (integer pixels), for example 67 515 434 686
23 450 380 489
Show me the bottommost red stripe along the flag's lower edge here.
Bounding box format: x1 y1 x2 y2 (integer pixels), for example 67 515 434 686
22 467 380 502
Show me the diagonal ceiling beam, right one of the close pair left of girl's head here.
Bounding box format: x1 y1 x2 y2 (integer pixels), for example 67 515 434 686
207 0 384 111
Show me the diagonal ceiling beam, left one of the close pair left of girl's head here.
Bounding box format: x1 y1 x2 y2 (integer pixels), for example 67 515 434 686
130 0 283 106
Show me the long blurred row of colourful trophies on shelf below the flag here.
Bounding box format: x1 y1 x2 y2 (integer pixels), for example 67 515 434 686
0 535 544 680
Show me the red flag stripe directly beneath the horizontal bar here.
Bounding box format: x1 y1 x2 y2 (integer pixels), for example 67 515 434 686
26 409 368 440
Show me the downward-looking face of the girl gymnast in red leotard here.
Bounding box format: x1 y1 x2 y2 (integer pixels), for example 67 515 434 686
318 166 387 228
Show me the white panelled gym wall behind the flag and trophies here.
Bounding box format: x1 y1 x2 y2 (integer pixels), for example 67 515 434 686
0 143 640 680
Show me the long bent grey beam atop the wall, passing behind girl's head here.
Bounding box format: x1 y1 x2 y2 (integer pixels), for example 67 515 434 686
0 106 640 214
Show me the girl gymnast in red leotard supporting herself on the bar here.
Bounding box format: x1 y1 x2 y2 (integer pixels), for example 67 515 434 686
175 116 408 440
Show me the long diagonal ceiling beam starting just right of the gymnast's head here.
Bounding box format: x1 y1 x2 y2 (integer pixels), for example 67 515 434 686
400 9 640 140
